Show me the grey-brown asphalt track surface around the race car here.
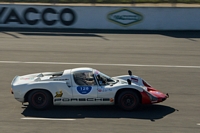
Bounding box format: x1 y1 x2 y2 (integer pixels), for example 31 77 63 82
0 32 200 133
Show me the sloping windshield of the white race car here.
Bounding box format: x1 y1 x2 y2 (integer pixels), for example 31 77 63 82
94 70 116 85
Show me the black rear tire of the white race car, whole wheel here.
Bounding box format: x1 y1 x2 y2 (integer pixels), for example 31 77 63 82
28 90 52 110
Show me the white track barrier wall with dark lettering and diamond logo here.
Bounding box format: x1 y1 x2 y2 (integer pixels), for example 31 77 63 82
0 4 200 30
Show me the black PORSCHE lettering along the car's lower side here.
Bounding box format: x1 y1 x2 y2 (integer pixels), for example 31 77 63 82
61 98 111 102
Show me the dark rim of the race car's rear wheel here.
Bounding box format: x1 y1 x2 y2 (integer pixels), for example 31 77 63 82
32 93 46 107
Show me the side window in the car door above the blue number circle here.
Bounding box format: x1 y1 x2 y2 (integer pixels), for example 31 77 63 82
73 72 96 86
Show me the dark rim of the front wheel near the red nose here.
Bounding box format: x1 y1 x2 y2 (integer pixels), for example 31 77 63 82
121 94 136 108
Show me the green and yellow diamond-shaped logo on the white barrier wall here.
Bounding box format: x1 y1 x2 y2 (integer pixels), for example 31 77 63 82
107 9 143 26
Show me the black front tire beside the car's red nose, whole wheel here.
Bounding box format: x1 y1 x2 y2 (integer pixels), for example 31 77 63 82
118 91 139 111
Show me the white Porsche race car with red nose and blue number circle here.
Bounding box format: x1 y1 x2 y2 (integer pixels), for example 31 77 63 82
11 68 168 110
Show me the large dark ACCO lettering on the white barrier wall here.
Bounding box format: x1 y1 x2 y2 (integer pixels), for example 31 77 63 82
0 7 76 26
